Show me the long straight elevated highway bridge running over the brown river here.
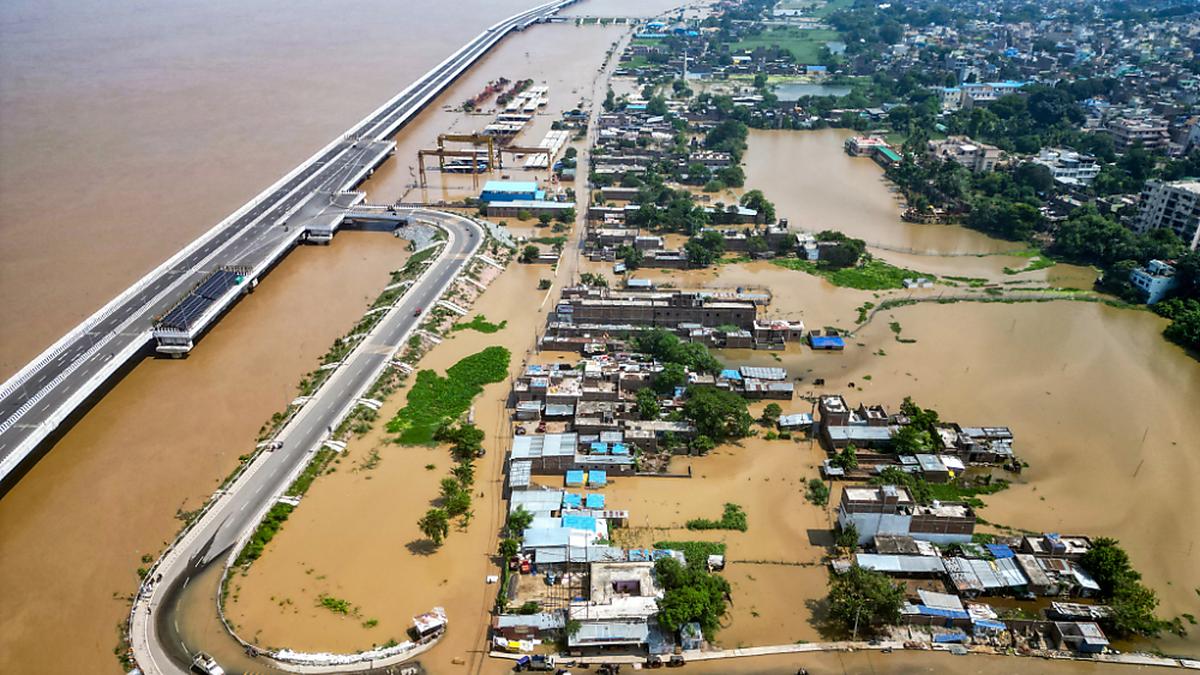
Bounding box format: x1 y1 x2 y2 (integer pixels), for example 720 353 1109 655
0 0 574 482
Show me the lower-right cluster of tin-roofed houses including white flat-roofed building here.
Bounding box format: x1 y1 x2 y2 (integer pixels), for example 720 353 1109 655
833 485 1109 652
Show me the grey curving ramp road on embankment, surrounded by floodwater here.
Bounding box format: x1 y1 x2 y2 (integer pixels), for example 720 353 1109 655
131 210 484 674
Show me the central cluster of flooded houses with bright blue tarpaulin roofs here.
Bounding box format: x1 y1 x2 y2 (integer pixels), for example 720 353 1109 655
492 354 724 656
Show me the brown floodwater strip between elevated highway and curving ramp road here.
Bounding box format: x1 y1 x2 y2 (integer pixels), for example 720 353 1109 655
0 232 408 673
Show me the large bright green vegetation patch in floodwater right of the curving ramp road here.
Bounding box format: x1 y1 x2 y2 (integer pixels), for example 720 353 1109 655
388 347 511 446
